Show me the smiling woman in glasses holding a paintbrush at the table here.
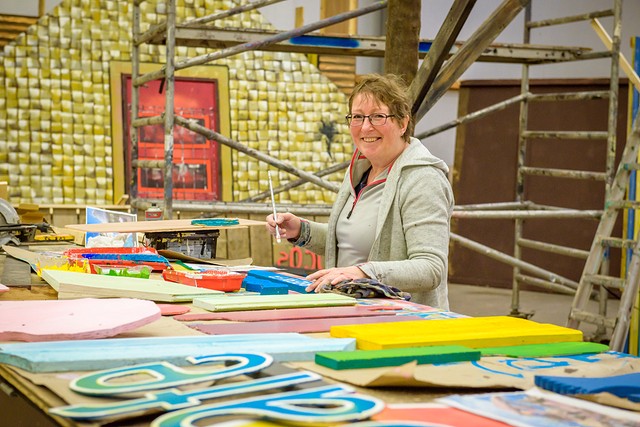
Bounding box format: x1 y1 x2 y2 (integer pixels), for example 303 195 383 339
267 74 453 310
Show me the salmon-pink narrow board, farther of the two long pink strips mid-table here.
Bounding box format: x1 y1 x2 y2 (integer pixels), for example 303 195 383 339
174 305 398 322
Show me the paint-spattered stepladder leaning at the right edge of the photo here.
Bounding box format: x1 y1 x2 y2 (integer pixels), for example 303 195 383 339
567 114 640 351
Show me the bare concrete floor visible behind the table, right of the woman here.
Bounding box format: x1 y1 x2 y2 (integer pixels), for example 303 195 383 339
449 284 619 337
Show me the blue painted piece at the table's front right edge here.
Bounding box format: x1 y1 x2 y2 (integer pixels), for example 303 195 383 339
535 372 640 402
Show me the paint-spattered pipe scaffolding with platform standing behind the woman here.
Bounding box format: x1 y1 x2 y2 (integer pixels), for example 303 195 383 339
130 0 636 342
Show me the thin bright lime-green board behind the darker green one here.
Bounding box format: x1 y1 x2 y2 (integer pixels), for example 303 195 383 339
480 341 609 357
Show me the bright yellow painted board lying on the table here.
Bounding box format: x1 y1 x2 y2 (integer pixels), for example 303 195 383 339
331 316 582 350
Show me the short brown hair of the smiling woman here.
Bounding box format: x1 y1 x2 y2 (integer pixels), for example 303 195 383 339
349 74 413 142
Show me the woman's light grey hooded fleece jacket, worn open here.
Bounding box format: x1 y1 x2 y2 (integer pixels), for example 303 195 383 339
296 138 453 310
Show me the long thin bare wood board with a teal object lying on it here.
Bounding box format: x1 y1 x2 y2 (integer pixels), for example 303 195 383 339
65 219 266 233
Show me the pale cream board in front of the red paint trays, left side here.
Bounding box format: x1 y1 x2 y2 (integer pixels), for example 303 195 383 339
42 270 223 302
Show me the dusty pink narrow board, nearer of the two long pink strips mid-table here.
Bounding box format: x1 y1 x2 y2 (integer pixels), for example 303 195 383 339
189 316 420 335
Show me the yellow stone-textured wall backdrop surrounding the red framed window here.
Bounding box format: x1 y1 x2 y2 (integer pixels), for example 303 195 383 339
0 0 352 205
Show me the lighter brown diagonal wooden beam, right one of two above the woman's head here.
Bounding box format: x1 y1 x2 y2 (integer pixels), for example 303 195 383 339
415 0 529 121
